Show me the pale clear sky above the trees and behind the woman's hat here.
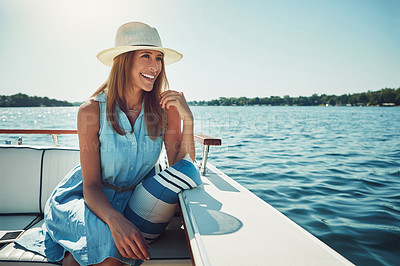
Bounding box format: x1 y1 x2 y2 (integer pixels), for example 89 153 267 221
0 0 400 101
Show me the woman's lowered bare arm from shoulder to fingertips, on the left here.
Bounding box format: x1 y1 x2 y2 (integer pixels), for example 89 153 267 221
78 100 149 260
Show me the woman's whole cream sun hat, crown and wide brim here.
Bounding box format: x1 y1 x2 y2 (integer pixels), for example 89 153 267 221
97 22 183 66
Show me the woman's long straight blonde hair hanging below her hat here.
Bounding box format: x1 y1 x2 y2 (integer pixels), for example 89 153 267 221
92 51 168 140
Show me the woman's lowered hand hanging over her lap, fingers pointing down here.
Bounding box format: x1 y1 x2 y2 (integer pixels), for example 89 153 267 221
108 215 150 260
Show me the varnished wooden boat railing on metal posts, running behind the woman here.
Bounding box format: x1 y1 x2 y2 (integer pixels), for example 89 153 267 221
0 129 221 175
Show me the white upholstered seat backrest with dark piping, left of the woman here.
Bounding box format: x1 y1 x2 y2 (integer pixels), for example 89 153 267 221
0 145 79 214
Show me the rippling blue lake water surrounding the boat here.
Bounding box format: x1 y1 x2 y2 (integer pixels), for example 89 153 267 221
0 106 400 265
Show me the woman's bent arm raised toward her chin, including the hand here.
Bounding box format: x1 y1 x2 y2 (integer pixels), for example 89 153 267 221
160 90 195 165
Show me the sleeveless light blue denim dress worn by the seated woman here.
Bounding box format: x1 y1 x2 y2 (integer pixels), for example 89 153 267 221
17 93 163 265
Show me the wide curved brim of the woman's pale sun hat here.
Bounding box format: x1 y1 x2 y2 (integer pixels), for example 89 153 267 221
97 46 183 67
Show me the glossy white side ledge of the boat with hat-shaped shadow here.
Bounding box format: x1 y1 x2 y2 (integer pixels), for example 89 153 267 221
180 164 352 265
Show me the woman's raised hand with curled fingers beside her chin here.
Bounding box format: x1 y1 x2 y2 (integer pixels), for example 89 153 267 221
160 90 193 122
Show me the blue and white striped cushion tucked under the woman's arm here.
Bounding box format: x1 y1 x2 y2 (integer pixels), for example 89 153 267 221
124 155 202 243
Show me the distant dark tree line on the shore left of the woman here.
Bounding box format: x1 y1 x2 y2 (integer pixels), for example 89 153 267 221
0 93 73 107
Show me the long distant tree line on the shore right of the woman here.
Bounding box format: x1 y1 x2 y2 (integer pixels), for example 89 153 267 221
189 88 400 106
